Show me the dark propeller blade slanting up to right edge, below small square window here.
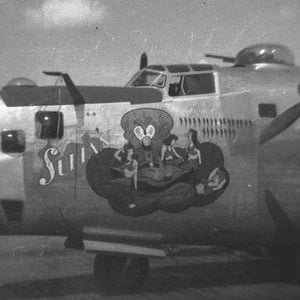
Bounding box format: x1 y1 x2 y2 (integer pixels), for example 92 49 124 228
259 103 300 145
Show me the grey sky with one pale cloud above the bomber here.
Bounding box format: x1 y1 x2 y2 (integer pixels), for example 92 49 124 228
0 0 300 86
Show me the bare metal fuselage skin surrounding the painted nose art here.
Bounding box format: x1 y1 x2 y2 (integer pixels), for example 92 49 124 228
0 65 300 251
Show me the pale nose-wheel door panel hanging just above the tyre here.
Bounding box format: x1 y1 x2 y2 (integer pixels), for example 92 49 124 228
83 227 168 258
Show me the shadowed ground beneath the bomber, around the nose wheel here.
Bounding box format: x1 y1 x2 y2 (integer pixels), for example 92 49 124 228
0 236 300 300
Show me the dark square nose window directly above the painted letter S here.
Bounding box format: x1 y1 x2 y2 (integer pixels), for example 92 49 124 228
35 111 64 139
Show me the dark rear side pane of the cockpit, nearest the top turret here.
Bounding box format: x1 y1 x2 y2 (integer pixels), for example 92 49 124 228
183 73 215 95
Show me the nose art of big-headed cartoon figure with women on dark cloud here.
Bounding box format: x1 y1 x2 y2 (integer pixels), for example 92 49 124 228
86 108 229 216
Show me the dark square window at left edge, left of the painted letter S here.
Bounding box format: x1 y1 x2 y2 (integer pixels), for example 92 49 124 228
1 130 25 153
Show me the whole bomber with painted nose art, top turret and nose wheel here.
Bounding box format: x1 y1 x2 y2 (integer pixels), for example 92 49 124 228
0 44 300 290
